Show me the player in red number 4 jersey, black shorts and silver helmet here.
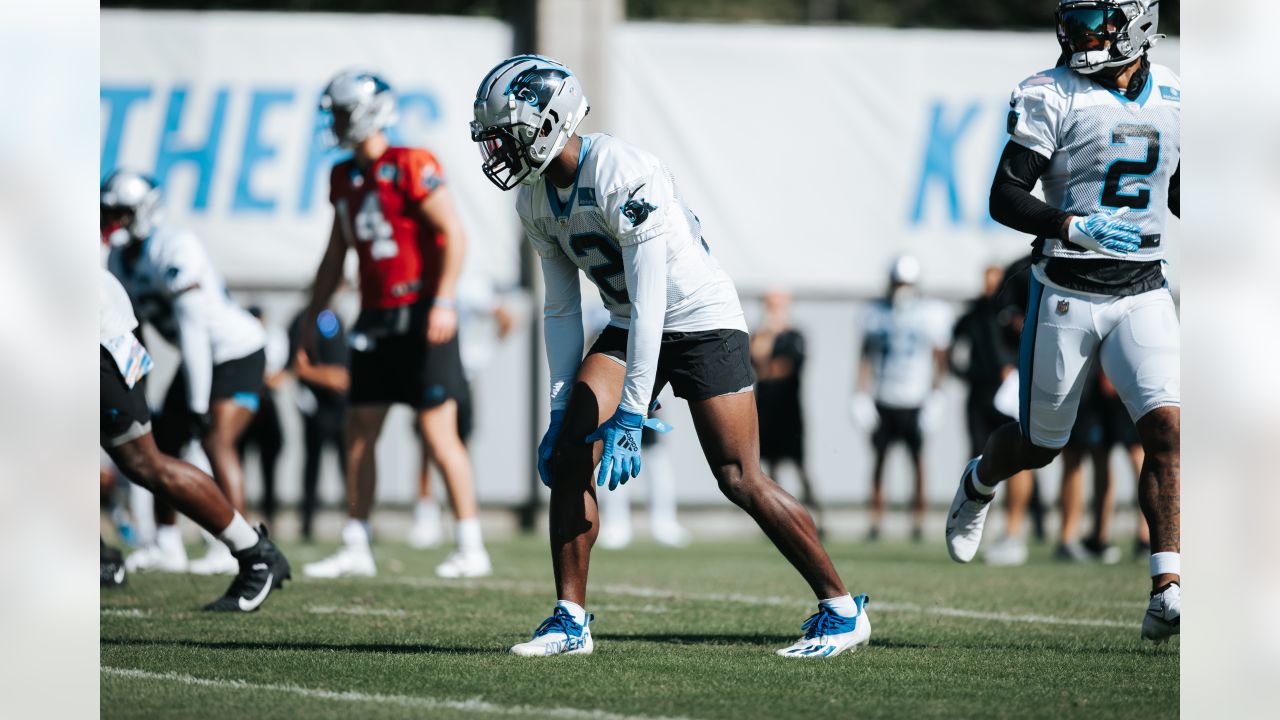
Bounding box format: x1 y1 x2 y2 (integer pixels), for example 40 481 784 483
301 70 492 578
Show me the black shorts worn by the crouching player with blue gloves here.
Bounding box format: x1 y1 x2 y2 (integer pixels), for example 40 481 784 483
588 325 755 402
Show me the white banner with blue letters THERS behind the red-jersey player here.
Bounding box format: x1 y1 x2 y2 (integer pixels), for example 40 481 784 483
101 10 518 288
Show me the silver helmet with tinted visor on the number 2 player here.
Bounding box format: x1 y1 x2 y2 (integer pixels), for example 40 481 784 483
1057 0 1165 74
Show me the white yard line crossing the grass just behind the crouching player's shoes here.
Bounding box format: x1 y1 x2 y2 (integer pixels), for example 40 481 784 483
396 578 1138 629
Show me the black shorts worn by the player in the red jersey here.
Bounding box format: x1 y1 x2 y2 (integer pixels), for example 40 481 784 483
347 304 468 410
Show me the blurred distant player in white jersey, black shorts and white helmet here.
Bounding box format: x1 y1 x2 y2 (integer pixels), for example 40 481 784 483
851 255 951 542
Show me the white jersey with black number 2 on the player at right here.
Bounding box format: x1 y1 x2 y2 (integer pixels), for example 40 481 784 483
1009 64 1181 261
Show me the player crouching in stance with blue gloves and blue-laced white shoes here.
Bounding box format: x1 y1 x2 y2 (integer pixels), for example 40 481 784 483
471 55 870 657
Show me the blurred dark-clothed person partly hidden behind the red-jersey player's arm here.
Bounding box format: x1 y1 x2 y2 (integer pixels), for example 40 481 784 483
289 307 351 542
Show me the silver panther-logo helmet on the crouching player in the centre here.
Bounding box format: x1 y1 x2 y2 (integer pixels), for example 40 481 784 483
471 55 591 190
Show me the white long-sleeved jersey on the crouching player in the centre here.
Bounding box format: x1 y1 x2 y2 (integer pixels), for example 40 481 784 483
516 135 746 414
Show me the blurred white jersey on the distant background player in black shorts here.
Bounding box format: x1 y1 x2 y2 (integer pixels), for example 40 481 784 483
863 297 951 407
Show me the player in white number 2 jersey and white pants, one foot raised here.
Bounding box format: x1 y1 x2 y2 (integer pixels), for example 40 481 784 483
947 0 1181 642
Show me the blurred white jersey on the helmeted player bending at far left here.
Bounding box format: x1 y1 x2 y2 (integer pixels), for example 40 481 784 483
106 228 266 364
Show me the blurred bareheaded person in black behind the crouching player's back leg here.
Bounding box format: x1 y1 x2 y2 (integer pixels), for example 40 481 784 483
751 288 822 534
